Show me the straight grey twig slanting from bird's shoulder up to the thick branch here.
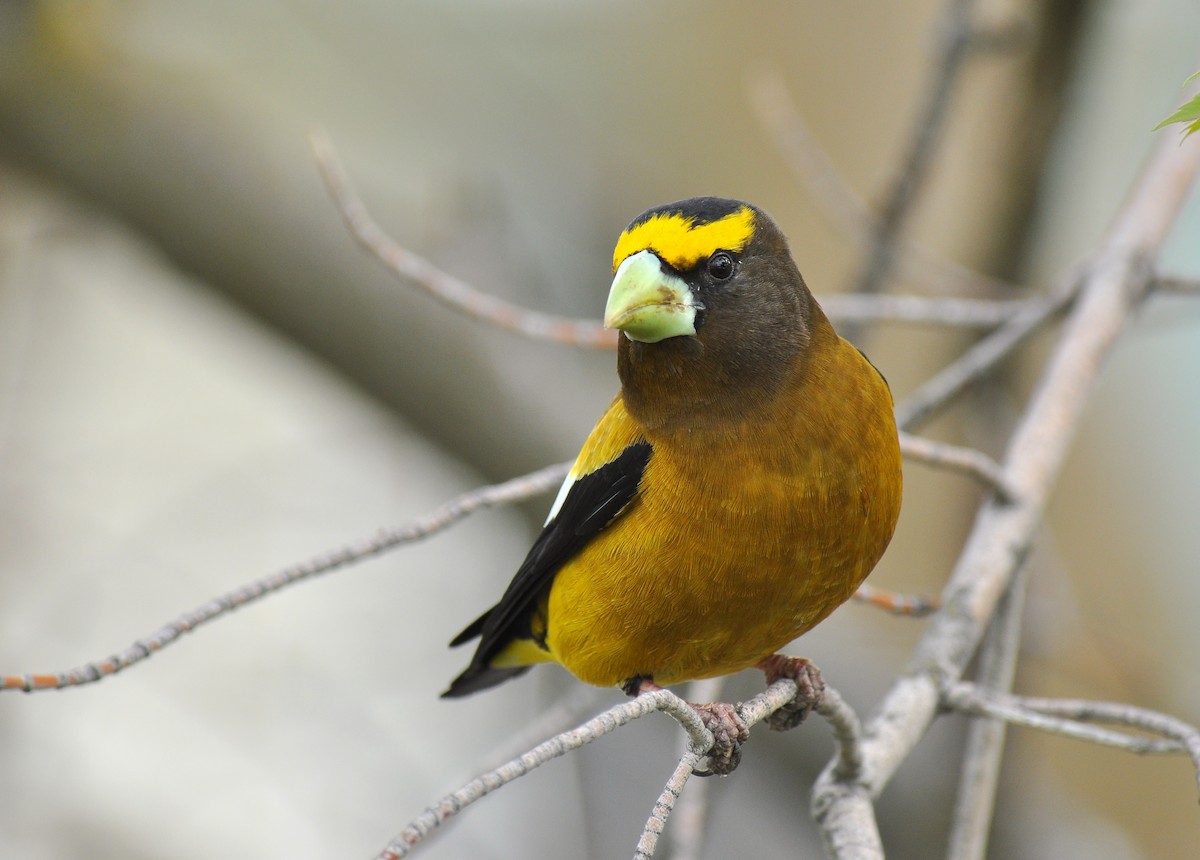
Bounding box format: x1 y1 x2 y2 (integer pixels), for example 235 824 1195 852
896 290 1078 431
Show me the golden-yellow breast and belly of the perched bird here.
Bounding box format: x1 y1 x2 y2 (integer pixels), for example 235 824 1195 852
545 338 901 685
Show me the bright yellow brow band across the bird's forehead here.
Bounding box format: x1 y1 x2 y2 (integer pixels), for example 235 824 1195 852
612 206 754 271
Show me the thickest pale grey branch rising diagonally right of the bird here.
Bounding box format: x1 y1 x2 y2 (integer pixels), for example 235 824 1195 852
814 105 1200 858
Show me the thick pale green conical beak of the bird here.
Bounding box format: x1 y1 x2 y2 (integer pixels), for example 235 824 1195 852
604 251 703 343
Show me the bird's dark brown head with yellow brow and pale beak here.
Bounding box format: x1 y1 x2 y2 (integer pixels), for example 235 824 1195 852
605 197 828 428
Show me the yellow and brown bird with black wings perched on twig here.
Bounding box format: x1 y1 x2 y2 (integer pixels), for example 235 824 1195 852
443 197 902 765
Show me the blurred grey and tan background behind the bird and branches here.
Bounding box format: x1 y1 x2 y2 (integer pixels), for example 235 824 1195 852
0 0 1200 860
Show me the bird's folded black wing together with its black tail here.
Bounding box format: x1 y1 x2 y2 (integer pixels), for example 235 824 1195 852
442 441 652 698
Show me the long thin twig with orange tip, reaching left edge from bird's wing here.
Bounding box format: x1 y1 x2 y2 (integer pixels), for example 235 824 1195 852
0 463 571 693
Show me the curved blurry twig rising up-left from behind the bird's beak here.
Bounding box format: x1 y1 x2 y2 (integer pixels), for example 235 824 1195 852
308 131 617 349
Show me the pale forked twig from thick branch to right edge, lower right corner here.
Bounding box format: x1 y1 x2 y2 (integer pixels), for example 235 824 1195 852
942 682 1200 784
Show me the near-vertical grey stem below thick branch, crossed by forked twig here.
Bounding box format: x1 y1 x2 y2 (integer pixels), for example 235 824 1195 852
946 564 1030 860
